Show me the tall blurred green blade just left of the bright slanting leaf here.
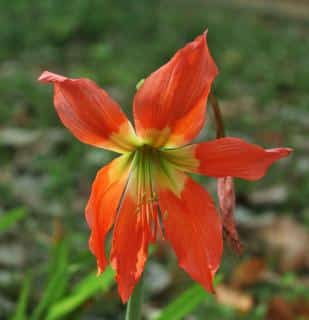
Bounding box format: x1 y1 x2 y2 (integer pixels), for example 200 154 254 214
31 240 69 320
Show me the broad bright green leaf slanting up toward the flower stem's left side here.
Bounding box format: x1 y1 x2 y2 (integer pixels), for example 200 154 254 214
47 267 114 320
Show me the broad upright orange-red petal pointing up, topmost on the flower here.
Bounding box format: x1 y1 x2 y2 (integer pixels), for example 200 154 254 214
134 33 218 146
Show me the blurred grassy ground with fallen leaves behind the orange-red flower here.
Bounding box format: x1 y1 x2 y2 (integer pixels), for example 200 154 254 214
0 0 309 320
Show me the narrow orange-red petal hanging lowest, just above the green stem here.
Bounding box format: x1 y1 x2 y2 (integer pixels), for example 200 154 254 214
111 179 152 303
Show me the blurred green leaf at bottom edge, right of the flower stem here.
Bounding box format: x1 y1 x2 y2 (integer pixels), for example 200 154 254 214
154 284 211 320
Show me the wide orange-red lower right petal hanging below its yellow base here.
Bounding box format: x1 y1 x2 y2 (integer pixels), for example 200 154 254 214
158 177 223 292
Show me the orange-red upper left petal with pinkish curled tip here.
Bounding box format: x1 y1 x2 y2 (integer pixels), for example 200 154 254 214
39 71 136 152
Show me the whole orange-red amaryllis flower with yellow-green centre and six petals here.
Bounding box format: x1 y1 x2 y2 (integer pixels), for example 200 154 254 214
39 34 291 302
